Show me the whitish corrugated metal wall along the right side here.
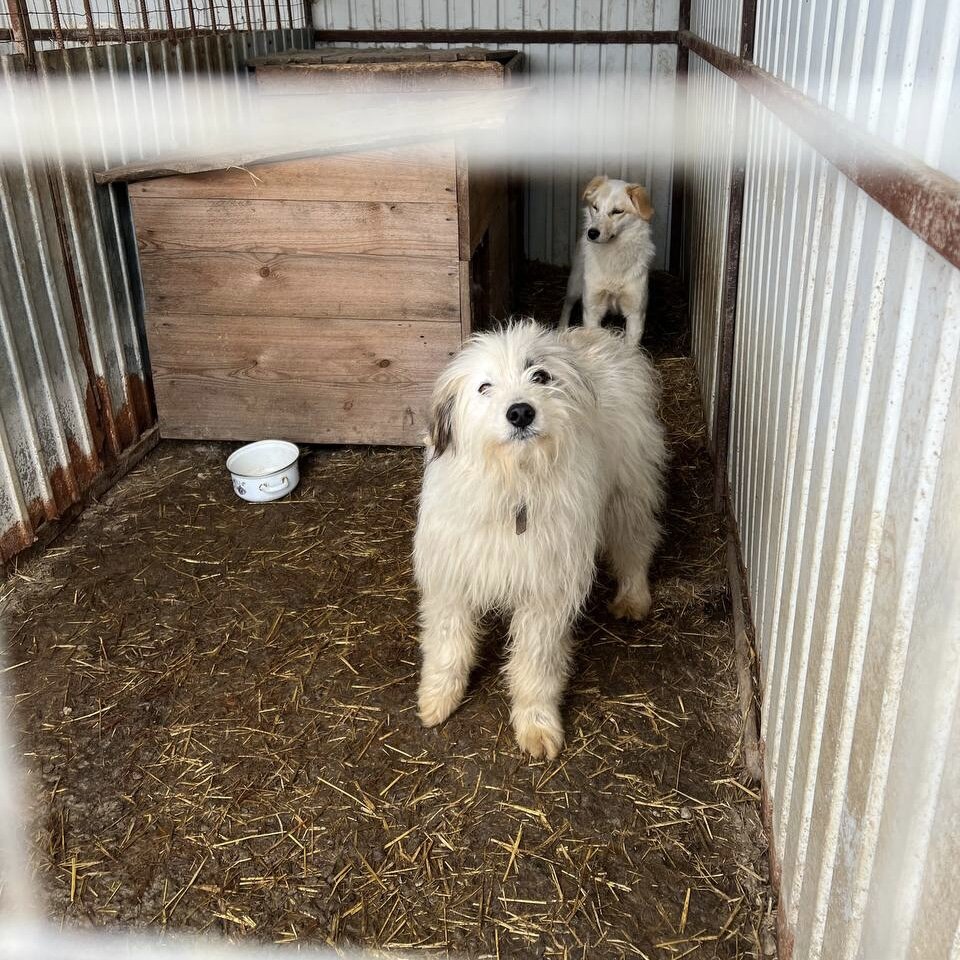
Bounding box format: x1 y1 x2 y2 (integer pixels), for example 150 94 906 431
690 0 960 960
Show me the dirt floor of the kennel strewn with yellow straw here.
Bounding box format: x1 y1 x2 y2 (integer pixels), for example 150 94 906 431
0 271 775 960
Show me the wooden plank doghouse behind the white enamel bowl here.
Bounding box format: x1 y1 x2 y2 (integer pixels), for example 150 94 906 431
99 50 516 444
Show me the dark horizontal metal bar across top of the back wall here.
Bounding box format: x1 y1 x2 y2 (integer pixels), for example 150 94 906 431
313 29 678 44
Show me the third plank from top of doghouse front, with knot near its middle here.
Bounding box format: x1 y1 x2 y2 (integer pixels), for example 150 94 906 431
140 251 460 322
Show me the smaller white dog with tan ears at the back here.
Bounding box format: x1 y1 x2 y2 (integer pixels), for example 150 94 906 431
560 177 655 346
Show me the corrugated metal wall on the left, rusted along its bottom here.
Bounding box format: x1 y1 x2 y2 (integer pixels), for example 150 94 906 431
0 30 310 559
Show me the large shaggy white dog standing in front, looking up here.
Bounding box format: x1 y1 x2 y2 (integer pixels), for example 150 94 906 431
414 320 666 757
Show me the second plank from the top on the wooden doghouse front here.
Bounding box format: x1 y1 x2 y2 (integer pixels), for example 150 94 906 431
132 197 458 257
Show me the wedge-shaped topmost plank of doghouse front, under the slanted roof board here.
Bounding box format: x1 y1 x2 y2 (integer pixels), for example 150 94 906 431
129 140 457 203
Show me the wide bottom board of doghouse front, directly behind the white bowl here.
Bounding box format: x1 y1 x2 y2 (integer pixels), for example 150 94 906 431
148 315 460 444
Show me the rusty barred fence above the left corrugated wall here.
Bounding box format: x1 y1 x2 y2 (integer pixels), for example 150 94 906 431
0 0 311 61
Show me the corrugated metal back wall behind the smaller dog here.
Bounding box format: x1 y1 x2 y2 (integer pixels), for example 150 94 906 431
314 0 679 268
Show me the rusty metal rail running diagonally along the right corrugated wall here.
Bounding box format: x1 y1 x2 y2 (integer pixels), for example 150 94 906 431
680 30 960 268
